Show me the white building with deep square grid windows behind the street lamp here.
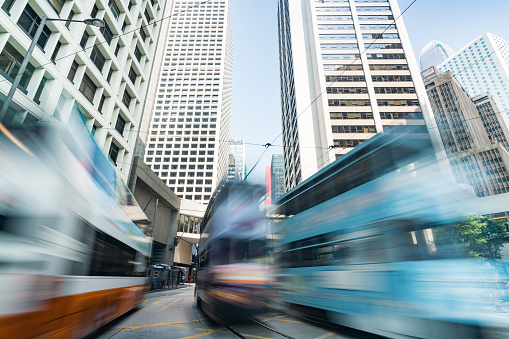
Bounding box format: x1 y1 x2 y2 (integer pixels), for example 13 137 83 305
0 0 170 181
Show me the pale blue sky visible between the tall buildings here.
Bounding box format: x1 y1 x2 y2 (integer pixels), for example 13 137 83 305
230 0 509 184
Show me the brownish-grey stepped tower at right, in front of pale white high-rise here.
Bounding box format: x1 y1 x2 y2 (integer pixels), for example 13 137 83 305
423 67 509 197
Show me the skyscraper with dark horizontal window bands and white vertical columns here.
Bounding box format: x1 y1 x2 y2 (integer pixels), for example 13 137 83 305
278 0 445 190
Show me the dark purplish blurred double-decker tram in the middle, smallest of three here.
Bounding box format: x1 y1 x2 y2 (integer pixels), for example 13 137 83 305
195 183 270 323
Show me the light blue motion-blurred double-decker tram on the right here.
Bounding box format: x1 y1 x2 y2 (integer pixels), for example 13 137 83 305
272 133 507 338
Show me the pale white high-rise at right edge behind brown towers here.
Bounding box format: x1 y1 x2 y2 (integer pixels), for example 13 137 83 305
438 33 509 126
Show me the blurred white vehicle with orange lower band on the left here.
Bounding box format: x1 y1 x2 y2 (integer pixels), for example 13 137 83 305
0 119 149 338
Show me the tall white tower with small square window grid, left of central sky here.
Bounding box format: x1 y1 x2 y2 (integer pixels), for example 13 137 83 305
144 0 233 204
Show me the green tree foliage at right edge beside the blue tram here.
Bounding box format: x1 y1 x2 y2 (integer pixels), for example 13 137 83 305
433 212 509 259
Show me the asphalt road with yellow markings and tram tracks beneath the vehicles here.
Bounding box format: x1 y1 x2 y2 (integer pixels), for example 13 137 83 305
90 286 362 339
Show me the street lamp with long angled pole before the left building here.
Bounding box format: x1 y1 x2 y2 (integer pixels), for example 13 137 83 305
0 16 105 122
